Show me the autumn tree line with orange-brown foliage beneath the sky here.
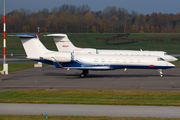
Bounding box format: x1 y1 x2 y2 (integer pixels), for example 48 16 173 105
0 4 180 33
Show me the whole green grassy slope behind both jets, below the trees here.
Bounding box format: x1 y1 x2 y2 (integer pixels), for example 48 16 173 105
0 33 180 53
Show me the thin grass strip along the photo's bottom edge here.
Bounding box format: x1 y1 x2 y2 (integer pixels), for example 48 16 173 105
0 115 180 120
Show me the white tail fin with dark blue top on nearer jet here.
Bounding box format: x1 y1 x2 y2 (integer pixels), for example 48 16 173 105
9 34 49 58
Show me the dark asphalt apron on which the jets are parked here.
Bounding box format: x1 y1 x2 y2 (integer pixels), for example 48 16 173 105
0 65 180 91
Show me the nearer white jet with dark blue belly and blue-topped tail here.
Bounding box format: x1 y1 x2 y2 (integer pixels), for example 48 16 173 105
9 34 175 77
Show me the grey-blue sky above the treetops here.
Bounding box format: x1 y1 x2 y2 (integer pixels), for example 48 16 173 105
0 0 180 14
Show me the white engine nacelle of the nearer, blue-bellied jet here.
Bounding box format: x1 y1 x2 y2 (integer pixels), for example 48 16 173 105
40 52 73 62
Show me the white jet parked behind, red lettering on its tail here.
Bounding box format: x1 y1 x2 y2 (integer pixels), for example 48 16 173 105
44 34 178 62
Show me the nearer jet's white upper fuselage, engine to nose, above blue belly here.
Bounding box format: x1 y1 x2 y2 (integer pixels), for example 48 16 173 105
74 54 174 68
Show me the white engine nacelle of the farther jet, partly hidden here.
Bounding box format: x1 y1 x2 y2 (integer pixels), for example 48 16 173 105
74 48 97 54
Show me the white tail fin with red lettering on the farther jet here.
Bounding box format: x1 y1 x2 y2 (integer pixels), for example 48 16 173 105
45 34 79 52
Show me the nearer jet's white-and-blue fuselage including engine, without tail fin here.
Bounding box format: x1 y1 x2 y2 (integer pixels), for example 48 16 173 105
40 52 174 70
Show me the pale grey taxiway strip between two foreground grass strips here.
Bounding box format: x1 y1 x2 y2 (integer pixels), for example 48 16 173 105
0 103 180 118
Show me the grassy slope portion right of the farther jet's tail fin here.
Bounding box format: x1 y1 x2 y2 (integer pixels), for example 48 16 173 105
64 33 180 53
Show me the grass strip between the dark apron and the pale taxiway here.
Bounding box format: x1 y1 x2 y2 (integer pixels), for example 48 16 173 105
0 90 180 106
